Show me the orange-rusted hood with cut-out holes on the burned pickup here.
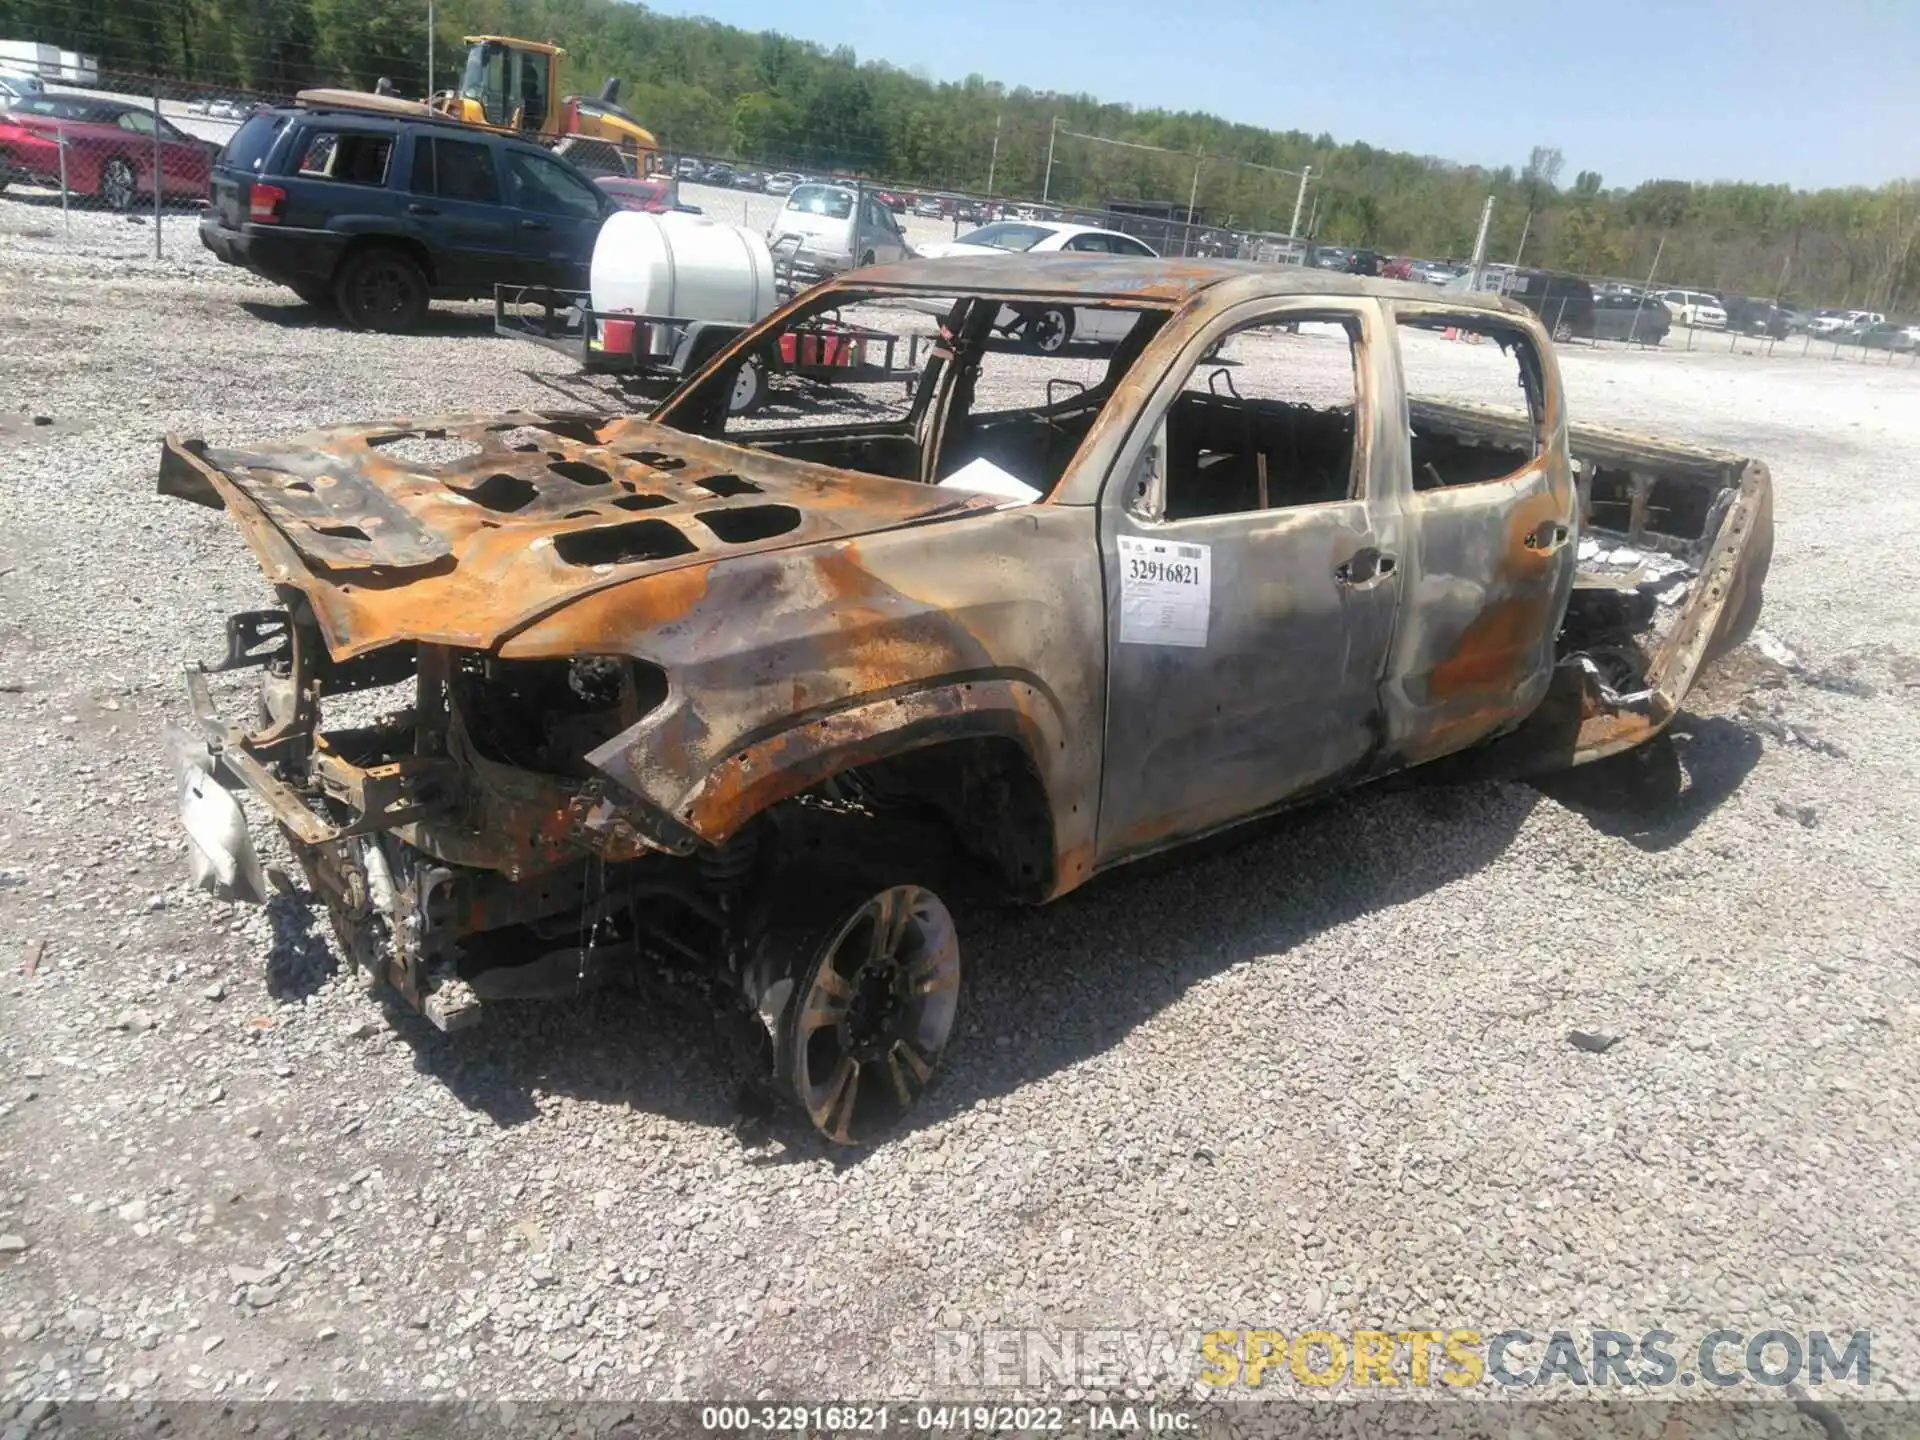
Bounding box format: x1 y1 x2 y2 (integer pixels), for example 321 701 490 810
159 411 981 659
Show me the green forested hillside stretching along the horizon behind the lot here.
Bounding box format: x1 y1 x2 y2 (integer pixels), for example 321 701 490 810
15 0 1920 309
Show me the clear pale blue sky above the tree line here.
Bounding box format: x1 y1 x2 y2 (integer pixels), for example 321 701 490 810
651 0 1920 188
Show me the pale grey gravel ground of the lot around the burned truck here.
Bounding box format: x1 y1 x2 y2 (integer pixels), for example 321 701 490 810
0 198 1920 1419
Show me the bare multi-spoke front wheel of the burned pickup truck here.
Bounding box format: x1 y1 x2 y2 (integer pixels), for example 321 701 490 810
749 858 962 1144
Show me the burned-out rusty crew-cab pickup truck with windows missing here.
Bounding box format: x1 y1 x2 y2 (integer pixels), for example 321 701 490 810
159 255 1772 1142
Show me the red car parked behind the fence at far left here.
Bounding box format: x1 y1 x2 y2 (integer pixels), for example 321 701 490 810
0 94 221 209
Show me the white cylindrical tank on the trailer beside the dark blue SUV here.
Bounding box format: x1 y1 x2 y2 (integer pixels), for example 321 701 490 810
588 209 780 355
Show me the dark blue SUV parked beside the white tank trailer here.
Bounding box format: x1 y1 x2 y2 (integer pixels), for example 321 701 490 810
200 96 616 330
